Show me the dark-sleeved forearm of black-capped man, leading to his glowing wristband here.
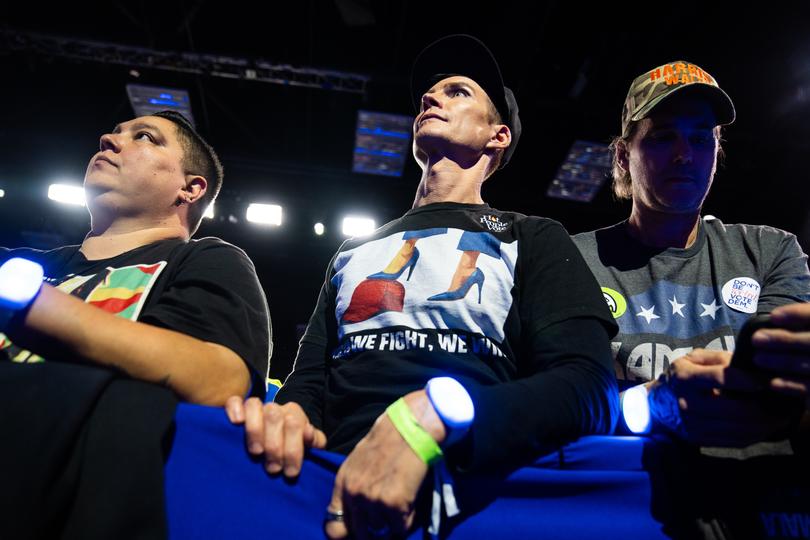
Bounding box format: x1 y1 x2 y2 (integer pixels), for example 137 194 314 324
463 319 618 470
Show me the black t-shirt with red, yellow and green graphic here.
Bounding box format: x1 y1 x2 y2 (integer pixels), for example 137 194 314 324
0 238 271 397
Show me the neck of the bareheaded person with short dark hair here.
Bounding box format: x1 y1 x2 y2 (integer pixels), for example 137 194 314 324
81 213 190 260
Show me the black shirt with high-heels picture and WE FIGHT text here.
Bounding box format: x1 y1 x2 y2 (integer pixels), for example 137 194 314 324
276 203 617 469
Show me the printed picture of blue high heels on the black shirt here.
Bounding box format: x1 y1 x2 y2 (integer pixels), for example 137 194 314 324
332 228 517 341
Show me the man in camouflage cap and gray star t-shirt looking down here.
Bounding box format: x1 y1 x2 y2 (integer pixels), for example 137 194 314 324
574 61 810 447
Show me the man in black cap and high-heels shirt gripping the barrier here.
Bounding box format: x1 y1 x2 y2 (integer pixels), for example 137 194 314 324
228 35 617 538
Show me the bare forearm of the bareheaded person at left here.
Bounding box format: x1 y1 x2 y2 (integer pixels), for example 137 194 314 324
7 285 250 405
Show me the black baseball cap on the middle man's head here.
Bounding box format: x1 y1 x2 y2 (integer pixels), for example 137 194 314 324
411 34 521 168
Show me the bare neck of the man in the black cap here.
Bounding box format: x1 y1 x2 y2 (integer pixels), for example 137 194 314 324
413 157 488 208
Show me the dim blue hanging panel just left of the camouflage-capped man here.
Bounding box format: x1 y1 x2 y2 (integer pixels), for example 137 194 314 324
546 141 611 202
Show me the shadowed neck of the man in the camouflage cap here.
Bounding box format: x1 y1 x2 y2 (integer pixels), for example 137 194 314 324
627 203 700 249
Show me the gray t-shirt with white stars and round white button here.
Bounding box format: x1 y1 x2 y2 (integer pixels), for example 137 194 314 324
573 219 810 390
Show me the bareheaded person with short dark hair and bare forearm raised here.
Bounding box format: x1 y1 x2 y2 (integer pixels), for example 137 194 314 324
0 111 270 405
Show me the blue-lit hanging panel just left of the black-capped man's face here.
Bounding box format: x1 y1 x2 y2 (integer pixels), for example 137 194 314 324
352 111 413 176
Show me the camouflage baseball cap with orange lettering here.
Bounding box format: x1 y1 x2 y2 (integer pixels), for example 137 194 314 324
622 60 736 137
